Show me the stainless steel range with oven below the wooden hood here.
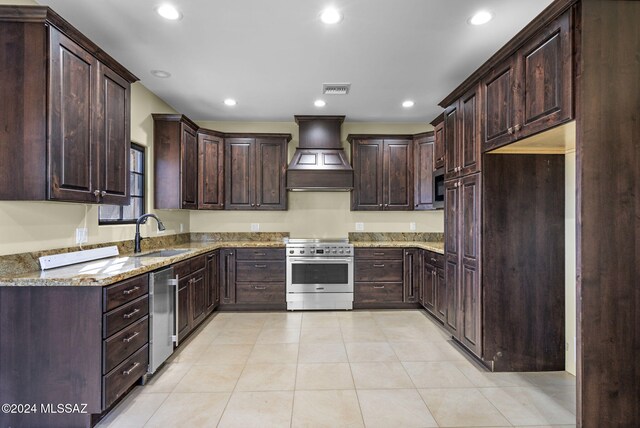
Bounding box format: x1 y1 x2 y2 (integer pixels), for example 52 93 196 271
286 239 353 310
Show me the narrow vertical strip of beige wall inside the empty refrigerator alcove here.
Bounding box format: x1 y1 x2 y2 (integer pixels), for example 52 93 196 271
564 150 576 375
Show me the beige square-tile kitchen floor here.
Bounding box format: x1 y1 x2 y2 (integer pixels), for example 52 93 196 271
98 310 575 428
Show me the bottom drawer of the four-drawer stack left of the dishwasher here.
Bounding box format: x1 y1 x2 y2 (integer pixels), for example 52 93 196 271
102 345 149 409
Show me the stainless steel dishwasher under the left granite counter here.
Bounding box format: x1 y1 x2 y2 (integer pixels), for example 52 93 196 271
147 267 178 374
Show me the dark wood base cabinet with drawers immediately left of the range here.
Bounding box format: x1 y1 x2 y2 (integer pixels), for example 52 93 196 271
220 248 286 309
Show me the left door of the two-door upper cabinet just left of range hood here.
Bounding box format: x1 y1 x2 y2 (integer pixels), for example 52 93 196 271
224 138 255 210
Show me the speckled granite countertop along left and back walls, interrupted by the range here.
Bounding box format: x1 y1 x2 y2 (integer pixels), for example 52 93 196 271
0 233 444 287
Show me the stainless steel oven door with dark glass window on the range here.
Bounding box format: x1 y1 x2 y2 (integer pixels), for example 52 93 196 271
287 257 353 293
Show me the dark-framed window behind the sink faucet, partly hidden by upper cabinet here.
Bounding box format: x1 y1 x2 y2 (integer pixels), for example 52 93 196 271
98 143 145 225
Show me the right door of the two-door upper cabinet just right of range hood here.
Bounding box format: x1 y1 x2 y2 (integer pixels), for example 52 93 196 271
382 140 413 211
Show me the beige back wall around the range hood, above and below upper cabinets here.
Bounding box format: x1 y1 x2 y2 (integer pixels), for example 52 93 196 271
191 121 444 238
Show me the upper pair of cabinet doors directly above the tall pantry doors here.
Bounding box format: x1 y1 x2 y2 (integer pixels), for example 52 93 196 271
444 85 480 180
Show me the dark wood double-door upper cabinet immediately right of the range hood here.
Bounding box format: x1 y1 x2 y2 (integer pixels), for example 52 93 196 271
347 135 414 211
